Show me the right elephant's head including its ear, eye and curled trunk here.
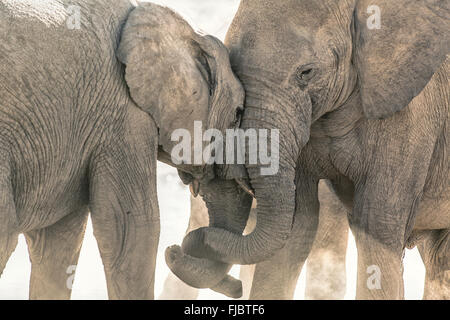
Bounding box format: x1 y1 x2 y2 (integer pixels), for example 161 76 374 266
163 0 450 292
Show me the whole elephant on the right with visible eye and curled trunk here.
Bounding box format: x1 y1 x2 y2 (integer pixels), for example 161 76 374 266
170 0 450 299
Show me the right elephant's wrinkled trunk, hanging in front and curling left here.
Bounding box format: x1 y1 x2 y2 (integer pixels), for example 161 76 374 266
182 81 311 264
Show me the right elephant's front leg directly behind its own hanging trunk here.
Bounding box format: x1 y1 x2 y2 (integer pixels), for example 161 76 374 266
250 172 319 300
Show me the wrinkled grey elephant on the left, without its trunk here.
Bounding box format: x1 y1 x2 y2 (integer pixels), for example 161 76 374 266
0 0 244 299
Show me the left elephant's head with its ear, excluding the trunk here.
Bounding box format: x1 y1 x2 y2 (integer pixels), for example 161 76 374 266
117 3 244 173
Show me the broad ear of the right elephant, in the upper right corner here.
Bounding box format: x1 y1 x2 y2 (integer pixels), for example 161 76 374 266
353 0 450 119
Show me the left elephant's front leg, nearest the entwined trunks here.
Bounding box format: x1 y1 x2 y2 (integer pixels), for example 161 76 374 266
91 150 160 300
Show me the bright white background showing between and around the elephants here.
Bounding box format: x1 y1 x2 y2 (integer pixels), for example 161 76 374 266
0 0 425 299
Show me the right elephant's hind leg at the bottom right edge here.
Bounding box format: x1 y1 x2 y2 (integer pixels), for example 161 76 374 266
418 229 450 300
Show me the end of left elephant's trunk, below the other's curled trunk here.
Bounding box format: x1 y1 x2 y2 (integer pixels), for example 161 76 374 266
165 245 242 299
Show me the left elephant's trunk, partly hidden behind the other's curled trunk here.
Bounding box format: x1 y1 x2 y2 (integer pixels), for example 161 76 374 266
166 178 253 298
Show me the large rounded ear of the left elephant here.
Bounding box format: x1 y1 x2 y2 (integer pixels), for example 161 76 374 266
117 3 216 148
